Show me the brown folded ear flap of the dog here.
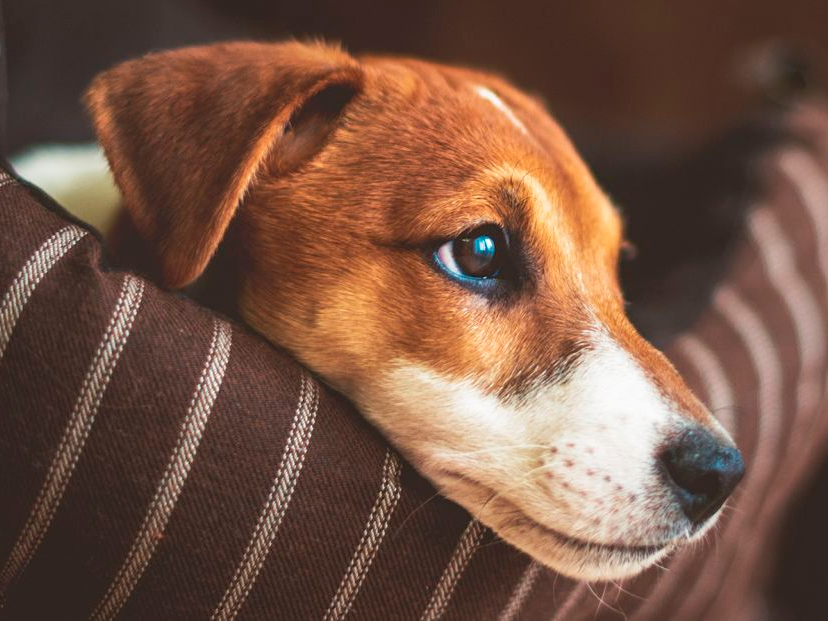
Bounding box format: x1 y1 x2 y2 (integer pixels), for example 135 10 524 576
86 42 363 288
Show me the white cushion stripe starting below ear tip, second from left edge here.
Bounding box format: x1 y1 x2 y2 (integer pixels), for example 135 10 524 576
0 274 144 604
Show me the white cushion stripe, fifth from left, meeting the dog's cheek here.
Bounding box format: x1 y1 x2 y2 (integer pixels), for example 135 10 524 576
325 449 402 621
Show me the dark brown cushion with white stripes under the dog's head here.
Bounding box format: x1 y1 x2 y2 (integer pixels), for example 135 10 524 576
0 99 828 620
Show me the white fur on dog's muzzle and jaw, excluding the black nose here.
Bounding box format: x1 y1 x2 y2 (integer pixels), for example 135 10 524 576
357 330 691 579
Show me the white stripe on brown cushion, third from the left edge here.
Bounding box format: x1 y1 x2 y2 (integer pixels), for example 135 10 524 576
92 320 232 620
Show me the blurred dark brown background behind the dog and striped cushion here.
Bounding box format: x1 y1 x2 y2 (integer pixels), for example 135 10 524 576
4 0 828 619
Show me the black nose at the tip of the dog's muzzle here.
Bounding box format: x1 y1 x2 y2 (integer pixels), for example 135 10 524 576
661 427 745 524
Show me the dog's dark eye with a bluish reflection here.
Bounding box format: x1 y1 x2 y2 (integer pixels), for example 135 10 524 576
434 225 508 279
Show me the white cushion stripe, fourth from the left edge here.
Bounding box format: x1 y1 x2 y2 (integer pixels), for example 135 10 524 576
212 374 319 620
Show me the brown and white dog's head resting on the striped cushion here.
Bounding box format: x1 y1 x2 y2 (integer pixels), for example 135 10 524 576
88 43 743 579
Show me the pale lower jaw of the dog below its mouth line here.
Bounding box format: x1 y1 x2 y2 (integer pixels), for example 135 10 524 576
440 473 719 581
